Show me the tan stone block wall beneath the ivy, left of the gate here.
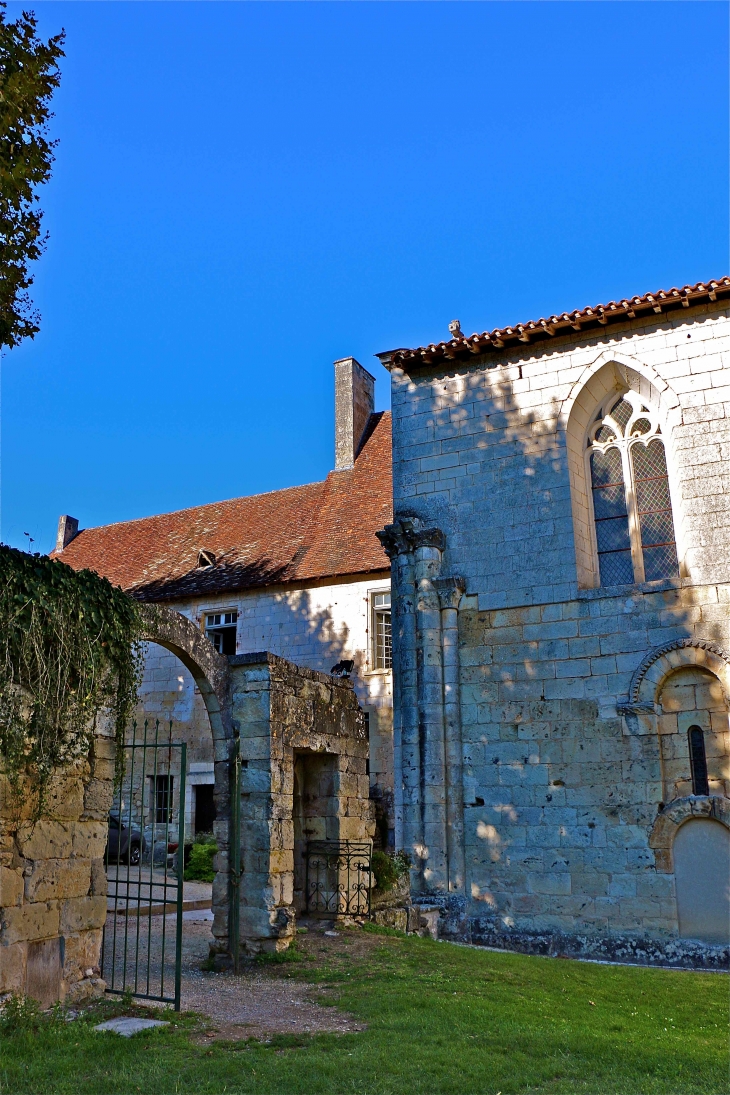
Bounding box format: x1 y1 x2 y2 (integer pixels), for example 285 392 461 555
0 727 114 1006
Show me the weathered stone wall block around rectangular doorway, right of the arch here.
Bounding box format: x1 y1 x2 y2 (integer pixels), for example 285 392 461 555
207 654 374 953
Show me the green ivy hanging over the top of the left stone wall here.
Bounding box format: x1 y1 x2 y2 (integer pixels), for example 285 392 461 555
0 545 142 818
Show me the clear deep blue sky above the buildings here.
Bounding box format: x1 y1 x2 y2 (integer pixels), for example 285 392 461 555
0 2 729 551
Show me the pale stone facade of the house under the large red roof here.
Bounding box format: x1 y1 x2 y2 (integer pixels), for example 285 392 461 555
137 572 393 835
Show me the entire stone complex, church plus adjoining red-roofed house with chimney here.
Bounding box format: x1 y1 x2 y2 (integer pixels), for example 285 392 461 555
58 278 730 965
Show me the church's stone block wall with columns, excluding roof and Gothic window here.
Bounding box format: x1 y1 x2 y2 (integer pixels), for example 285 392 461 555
385 303 730 960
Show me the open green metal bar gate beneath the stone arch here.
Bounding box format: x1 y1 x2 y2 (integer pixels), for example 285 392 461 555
102 721 186 1011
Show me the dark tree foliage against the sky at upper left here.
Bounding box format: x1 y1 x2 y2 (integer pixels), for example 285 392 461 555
0 3 65 347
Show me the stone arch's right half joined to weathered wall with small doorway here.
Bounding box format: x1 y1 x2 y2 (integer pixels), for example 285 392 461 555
138 606 374 955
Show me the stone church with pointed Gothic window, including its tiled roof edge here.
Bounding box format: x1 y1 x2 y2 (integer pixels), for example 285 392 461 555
379 278 730 960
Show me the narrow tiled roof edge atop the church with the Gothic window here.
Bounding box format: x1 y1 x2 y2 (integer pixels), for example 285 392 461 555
375 277 730 369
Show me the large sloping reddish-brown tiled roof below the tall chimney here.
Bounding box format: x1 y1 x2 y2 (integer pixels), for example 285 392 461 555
56 413 393 601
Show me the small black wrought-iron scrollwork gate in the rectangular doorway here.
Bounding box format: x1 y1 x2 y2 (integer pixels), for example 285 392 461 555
305 840 372 917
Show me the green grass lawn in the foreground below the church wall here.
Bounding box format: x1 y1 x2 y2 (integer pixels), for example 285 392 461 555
0 931 730 1095
